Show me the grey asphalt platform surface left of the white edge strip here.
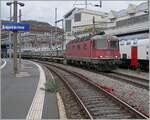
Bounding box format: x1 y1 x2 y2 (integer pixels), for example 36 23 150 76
1 59 39 119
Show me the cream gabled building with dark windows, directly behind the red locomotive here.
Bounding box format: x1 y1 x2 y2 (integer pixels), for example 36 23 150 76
64 8 110 48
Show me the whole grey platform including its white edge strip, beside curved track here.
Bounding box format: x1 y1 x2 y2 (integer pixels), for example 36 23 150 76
1 59 59 120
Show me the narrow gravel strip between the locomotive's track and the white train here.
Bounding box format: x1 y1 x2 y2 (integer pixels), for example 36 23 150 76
113 68 149 80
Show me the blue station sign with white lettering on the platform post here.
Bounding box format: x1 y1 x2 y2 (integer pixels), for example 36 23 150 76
1 22 29 31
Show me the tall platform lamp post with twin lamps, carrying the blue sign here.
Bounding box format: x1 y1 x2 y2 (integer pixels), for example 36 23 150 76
6 0 24 74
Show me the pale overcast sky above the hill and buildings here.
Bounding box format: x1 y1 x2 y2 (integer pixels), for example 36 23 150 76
1 0 146 26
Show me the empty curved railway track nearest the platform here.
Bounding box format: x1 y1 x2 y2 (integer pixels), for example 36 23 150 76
34 61 148 119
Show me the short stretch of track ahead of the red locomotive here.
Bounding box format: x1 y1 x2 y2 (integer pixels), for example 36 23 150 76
100 72 149 90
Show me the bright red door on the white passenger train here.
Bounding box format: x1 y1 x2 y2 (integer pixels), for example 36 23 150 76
131 46 138 67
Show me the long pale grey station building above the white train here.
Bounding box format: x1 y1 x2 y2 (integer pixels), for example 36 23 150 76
105 2 149 35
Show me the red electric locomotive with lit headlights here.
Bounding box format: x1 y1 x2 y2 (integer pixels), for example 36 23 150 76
66 34 120 71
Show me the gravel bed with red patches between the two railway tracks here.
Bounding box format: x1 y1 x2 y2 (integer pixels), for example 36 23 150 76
57 64 149 115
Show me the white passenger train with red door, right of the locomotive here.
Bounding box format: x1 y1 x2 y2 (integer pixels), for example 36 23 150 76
119 33 150 70
